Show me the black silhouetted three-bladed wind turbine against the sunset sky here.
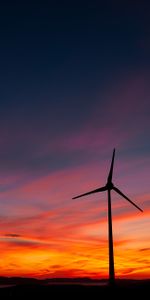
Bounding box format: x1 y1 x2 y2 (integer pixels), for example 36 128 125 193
72 149 143 284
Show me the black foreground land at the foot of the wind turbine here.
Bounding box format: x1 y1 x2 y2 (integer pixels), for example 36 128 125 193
0 280 150 299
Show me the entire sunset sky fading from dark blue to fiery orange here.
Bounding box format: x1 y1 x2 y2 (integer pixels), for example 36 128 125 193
0 0 150 278
